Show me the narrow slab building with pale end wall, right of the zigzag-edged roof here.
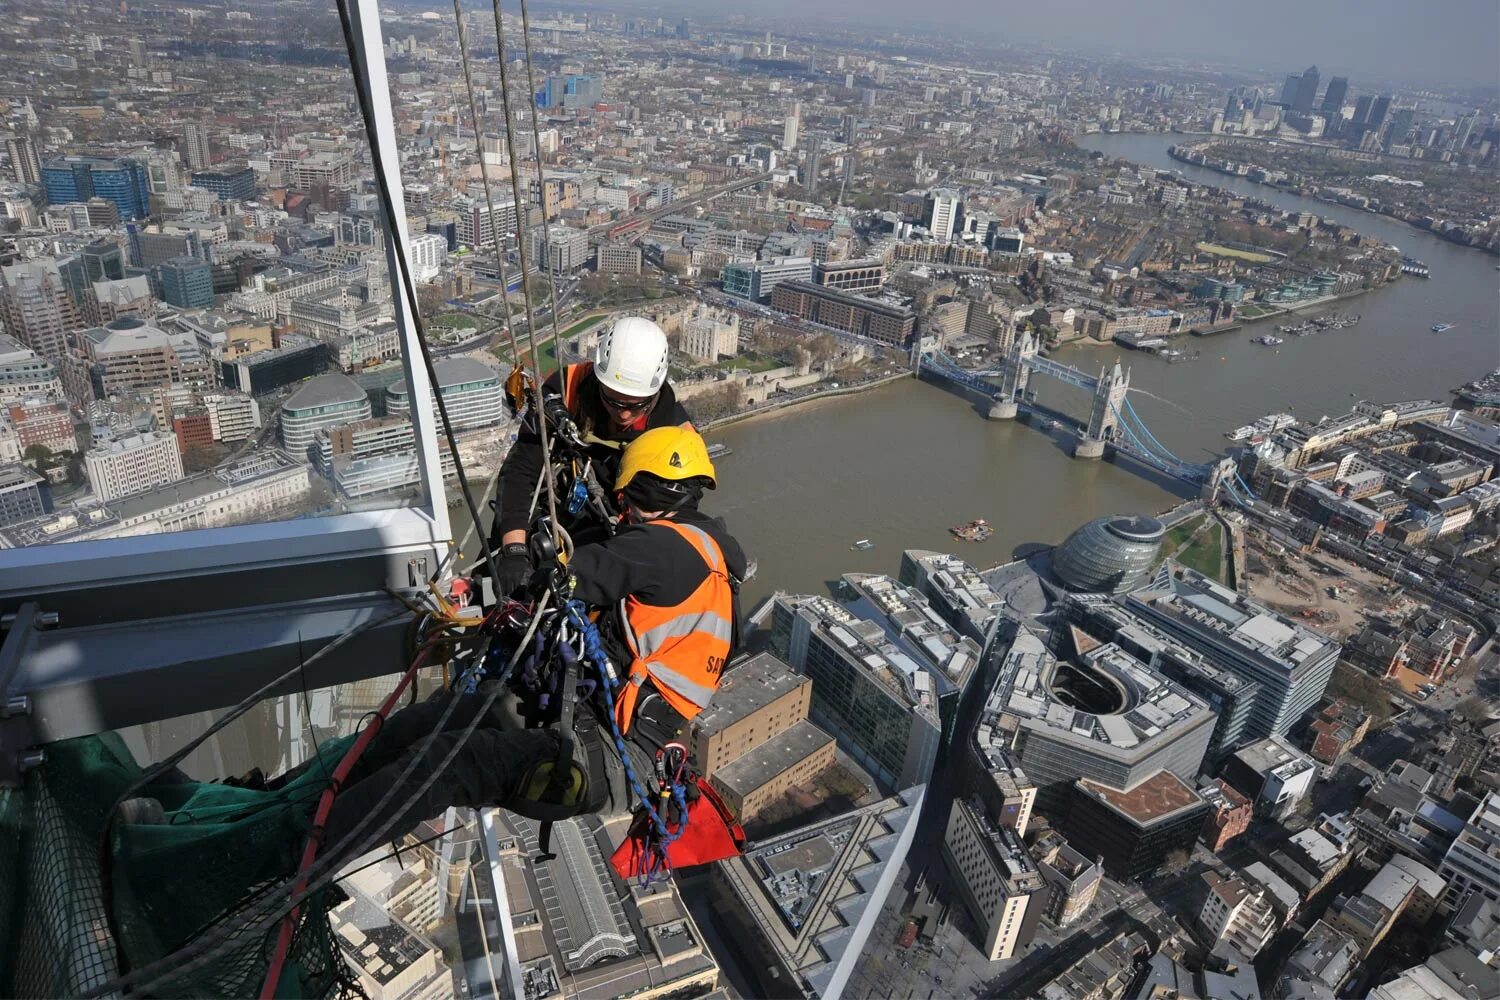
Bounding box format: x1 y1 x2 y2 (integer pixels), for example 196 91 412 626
942 798 1047 961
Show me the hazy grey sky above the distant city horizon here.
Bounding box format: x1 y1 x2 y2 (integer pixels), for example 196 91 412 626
654 0 1500 87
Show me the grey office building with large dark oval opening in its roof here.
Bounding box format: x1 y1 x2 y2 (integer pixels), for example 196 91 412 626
980 628 1214 809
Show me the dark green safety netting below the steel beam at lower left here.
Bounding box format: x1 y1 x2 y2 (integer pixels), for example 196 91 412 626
0 733 359 997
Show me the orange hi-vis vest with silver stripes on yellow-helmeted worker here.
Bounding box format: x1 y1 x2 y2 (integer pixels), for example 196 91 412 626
615 520 735 733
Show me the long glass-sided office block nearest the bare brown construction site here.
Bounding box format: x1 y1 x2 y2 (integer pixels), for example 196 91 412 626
1125 564 1340 738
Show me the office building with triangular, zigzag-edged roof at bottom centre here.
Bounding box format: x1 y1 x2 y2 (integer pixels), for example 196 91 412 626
713 787 926 999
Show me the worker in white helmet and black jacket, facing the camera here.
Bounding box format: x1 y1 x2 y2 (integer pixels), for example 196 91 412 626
491 316 693 594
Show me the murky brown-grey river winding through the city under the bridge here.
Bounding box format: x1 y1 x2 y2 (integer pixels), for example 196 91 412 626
705 128 1500 607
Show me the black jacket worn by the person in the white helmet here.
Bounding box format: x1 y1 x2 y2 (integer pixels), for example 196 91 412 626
491 364 692 549
